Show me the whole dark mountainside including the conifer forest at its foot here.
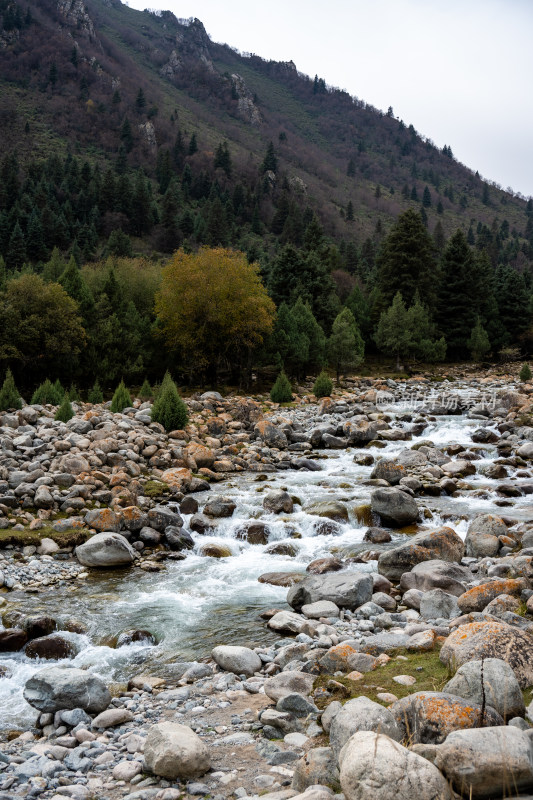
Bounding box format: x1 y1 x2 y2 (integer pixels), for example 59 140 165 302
0 0 533 394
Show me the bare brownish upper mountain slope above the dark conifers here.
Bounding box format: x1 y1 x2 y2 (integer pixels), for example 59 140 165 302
0 0 526 253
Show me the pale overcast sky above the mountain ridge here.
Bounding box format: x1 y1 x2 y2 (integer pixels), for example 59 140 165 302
122 0 533 196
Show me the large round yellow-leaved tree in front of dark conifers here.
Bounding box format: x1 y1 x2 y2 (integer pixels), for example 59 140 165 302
155 247 276 380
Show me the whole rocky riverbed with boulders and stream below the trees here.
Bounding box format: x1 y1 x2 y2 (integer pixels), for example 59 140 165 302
0 374 533 800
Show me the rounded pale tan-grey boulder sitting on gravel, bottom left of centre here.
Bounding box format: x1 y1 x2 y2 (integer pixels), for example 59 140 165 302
144 722 211 781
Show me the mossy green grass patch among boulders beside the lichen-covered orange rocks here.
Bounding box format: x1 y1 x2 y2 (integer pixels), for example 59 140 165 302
314 648 452 709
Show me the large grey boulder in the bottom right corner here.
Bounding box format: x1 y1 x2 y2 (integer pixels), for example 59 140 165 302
435 725 533 800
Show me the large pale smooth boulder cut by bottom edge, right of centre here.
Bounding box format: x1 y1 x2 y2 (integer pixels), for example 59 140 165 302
339 731 452 800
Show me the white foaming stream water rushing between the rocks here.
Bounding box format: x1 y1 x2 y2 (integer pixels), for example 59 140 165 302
0 400 530 729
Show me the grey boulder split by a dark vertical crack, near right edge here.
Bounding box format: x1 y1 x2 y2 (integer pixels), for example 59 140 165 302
443 658 526 720
